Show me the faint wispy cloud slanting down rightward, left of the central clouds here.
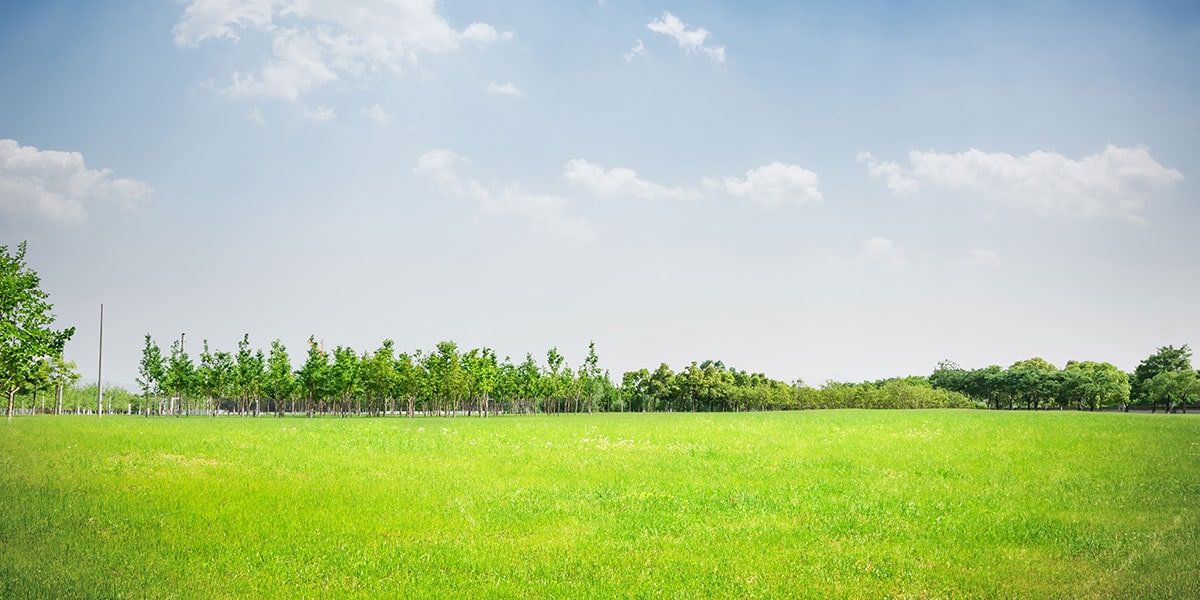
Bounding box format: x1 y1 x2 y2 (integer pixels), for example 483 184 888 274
413 149 599 241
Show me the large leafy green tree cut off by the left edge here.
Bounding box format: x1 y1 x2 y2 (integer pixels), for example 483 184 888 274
0 242 74 419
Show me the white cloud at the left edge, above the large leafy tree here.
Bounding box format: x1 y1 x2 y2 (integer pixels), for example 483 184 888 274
0 139 154 224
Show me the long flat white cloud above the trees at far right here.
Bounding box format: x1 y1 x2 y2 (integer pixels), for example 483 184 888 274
859 144 1183 220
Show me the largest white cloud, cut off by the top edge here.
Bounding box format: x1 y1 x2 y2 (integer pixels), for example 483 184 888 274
174 0 512 102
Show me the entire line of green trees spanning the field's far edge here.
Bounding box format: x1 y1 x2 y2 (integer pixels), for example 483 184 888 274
7 242 1200 416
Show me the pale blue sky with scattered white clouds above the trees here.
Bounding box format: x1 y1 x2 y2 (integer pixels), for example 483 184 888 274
0 0 1200 384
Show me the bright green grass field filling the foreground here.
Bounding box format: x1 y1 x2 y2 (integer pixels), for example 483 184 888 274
0 410 1200 599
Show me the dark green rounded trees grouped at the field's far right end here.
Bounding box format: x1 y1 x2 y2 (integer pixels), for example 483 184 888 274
929 344 1200 412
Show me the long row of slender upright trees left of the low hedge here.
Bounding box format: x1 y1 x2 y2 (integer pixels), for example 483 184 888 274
138 335 830 416
